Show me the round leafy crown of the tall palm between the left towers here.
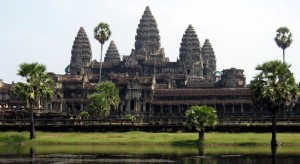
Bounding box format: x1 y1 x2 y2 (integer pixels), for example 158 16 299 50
94 22 111 44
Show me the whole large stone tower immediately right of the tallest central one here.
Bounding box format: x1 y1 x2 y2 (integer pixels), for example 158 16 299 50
179 25 203 77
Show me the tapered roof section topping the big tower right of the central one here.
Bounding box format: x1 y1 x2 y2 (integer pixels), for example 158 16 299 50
179 25 201 62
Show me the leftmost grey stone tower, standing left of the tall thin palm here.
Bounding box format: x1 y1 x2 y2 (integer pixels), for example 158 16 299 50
70 27 92 75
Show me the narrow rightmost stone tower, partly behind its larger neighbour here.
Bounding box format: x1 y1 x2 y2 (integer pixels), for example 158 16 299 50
201 39 217 81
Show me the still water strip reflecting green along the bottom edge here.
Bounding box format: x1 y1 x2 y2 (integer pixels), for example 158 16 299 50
0 145 300 164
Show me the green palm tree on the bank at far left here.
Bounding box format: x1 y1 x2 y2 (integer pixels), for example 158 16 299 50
12 63 54 139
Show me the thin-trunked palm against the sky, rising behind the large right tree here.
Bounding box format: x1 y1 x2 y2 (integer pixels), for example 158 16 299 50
274 27 293 62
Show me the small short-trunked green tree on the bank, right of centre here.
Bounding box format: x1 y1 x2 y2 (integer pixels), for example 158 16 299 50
185 106 217 142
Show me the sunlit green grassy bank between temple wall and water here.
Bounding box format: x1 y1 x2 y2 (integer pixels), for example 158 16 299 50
0 132 300 146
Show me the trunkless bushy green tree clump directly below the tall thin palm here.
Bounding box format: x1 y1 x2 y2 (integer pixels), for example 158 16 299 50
87 81 120 118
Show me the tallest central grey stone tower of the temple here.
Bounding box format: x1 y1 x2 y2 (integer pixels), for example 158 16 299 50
135 6 160 55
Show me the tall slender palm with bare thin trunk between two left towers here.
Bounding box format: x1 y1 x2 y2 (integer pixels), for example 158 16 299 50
94 22 111 83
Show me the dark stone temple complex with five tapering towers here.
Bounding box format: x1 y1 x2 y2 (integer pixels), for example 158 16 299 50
0 7 300 122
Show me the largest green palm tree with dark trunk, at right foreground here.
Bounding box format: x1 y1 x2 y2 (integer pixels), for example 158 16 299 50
250 60 299 146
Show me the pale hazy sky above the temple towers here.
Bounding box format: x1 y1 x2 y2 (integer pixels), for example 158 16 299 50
0 0 300 83
